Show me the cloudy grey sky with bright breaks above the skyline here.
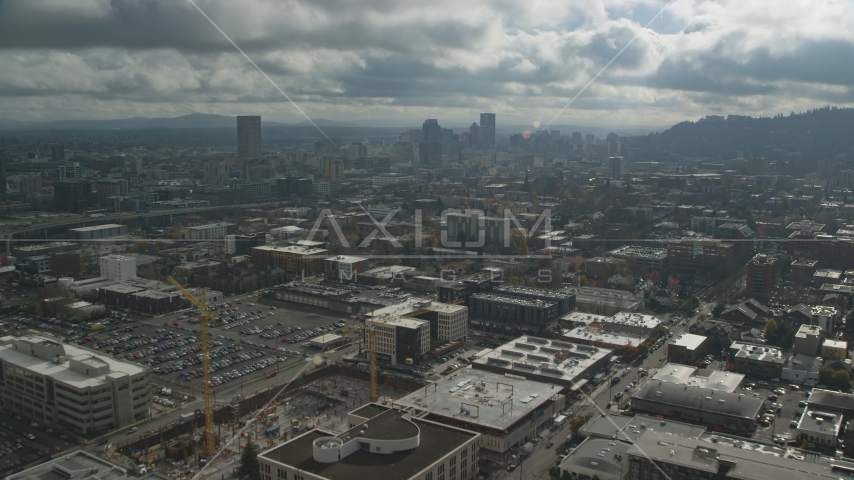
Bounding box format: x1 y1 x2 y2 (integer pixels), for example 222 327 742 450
0 0 854 126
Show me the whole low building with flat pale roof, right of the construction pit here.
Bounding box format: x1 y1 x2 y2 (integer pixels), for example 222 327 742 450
392 368 566 459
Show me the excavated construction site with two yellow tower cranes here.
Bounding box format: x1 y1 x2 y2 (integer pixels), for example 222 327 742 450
109 277 432 478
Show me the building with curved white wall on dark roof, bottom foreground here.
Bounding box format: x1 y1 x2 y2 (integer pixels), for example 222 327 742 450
258 404 480 480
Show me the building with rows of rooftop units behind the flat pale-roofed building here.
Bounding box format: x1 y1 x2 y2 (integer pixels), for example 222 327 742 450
472 335 612 392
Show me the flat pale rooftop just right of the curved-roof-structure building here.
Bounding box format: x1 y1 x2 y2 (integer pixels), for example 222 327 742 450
394 367 559 430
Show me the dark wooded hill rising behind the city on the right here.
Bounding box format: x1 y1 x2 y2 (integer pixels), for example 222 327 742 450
630 107 854 159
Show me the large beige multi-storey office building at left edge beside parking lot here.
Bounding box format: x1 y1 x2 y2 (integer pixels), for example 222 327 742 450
0 335 149 435
